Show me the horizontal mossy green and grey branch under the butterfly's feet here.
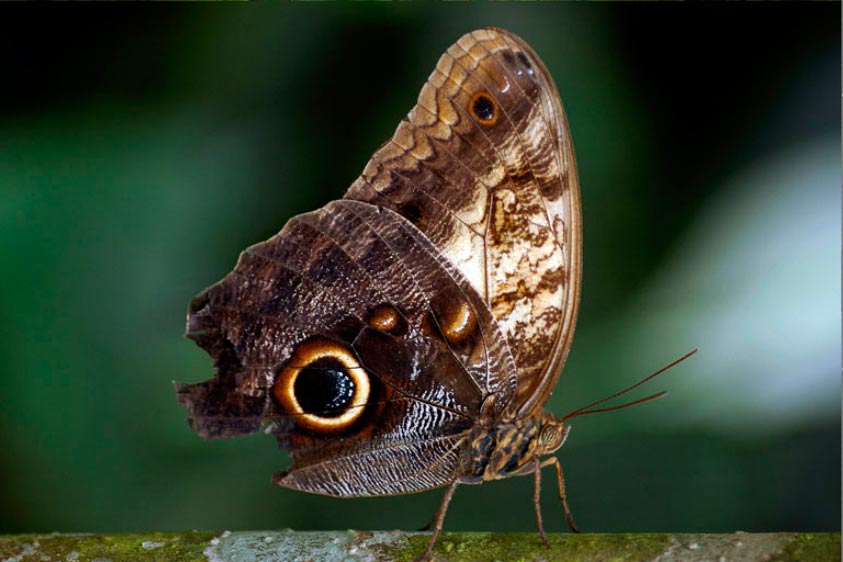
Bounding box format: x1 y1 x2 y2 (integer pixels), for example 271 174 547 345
0 531 840 562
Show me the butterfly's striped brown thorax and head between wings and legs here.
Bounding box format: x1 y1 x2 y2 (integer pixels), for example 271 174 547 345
465 411 570 480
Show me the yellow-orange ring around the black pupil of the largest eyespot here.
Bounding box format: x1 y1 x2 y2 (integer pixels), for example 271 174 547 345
272 339 371 433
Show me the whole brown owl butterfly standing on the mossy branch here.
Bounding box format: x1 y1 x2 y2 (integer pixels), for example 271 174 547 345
177 29 692 558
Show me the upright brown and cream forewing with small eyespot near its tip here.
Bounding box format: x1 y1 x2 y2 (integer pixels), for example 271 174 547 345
346 29 581 416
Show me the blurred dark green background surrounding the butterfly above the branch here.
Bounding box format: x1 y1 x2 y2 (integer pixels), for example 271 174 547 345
0 3 841 532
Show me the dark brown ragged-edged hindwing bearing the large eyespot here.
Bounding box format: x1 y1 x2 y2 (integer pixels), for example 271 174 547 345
179 195 514 496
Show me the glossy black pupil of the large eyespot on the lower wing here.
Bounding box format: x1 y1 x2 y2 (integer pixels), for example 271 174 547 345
293 360 355 417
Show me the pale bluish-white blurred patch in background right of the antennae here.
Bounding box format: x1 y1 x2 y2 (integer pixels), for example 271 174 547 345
620 138 841 433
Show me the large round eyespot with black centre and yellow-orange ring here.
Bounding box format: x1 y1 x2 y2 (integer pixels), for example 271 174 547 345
272 339 371 433
